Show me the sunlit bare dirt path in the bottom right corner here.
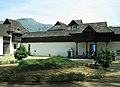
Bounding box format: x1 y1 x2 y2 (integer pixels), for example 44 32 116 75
74 58 120 87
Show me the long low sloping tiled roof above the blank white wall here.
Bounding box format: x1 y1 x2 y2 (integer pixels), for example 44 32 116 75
22 30 70 38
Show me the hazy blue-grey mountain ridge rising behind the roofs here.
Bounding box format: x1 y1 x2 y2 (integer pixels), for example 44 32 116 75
0 18 53 32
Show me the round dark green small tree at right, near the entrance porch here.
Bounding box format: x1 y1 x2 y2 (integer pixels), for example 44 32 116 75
94 48 113 70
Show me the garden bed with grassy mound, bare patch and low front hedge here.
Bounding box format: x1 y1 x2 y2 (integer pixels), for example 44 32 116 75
0 57 93 82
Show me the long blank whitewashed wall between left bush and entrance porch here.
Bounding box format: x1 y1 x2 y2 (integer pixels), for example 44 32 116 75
24 42 75 56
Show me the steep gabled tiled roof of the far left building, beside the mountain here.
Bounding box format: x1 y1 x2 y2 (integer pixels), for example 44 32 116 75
3 19 28 34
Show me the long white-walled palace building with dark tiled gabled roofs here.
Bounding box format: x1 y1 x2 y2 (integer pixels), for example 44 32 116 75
0 19 120 56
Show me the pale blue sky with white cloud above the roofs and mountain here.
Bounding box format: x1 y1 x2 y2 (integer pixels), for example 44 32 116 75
0 0 120 26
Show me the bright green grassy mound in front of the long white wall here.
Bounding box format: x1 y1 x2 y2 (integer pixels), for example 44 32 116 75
10 57 82 71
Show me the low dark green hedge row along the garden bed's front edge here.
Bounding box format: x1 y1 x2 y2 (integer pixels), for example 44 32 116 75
0 72 87 83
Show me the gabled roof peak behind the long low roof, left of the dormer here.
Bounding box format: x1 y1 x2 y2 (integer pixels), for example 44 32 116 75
48 21 68 31
